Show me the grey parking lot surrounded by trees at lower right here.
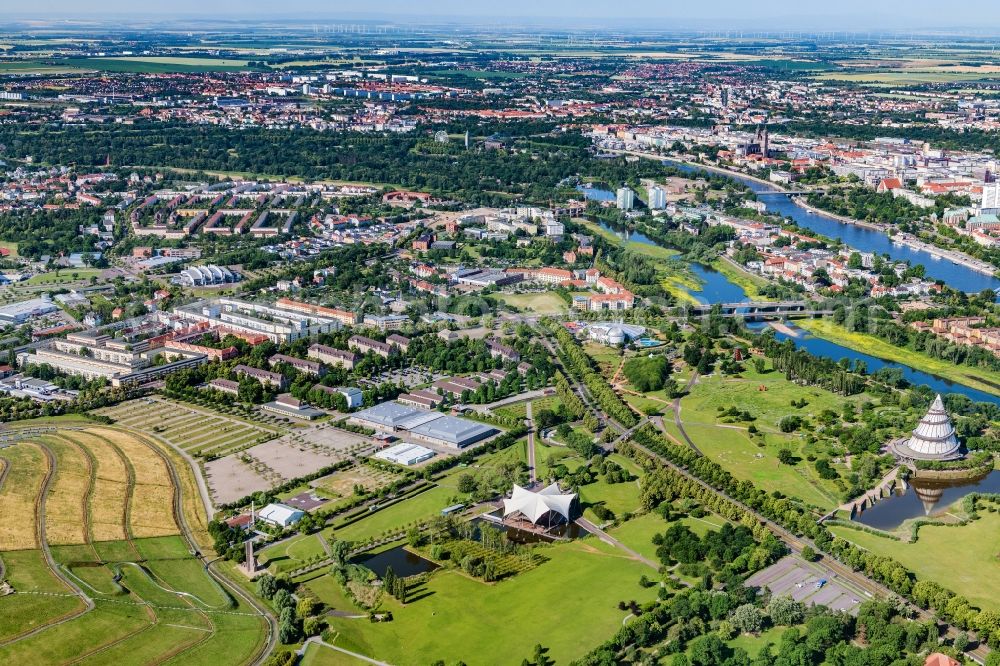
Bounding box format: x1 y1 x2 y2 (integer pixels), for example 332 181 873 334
746 555 869 615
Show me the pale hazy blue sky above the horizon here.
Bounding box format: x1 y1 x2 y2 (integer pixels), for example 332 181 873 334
13 0 1000 32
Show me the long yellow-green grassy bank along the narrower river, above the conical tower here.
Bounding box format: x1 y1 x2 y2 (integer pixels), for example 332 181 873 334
796 319 1000 395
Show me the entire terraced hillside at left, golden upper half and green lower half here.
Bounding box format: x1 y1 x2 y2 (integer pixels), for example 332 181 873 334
0 422 269 666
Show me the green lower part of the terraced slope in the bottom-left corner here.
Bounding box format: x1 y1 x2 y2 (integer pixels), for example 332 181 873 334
0 537 264 666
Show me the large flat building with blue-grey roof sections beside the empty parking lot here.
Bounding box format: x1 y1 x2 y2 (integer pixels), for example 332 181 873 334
350 402 499 449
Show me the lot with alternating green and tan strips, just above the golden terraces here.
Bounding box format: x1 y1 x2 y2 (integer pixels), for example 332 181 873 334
98 398 284 458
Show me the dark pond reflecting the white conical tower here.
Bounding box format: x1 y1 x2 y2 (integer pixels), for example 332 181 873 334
854 470 1000 530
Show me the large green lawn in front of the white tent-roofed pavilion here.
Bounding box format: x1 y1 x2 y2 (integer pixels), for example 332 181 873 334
331 538 656 664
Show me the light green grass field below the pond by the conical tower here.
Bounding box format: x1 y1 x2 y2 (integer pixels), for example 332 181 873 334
830 511 1000 610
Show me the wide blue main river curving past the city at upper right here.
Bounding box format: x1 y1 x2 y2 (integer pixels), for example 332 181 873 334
663 160 1000 293
